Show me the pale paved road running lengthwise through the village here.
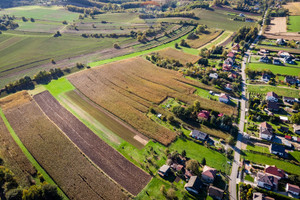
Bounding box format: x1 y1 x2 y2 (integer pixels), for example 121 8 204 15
229 11 266 200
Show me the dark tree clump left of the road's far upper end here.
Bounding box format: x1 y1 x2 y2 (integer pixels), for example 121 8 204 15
232 26 258 43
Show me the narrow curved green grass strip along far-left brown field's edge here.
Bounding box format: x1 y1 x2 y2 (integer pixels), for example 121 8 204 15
0 108 69 200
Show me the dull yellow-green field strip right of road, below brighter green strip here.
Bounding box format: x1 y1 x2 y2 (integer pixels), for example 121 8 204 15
247 85 300 98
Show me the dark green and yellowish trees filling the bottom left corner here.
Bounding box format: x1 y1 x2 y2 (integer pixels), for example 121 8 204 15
0 163 62 200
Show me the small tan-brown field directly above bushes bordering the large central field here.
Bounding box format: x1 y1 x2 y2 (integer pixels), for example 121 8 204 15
157 47 200 65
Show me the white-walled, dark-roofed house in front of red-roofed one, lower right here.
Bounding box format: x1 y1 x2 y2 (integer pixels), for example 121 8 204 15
255 172 278 190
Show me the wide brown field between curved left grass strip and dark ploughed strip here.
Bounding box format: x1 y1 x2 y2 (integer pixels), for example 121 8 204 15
0 92 129 200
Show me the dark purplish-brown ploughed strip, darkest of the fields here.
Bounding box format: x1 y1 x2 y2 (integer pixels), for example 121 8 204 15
34 91 151 195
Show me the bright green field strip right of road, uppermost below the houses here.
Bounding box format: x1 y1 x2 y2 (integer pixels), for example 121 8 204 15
248 62 300 76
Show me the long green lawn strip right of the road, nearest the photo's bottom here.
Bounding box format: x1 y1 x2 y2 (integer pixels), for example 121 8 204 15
243 152 300 175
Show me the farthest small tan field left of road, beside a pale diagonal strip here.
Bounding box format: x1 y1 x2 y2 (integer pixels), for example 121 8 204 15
186 30 223 49
